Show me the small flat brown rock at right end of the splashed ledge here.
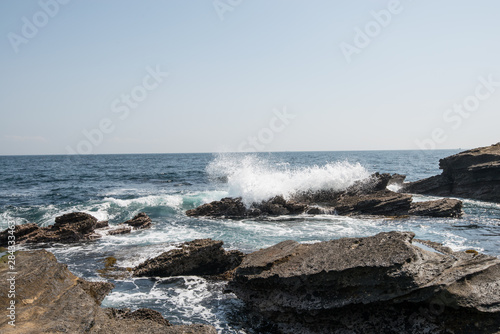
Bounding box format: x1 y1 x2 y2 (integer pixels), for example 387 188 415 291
408 198 463 218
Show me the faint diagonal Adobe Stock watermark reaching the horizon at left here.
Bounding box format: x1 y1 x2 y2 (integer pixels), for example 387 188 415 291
66 65 169 155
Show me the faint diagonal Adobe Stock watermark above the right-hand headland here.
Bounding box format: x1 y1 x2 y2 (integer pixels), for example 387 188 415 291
415 74 500 150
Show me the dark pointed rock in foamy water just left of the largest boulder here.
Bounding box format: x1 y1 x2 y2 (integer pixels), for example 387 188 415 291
134 239 243 277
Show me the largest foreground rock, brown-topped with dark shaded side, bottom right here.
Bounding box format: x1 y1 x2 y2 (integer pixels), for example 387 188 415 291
229 232 500 333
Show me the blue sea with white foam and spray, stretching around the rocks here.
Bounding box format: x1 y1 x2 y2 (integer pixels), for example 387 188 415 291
0 150 500 333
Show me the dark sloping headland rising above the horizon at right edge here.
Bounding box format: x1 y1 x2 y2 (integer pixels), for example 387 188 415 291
403 143 500 203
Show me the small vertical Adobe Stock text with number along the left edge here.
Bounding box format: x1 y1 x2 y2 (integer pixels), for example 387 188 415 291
7 221 17 326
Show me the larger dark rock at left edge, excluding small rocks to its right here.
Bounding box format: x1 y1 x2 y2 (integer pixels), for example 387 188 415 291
0 212 100 245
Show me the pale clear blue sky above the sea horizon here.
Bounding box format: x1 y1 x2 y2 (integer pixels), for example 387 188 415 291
0 0 500 155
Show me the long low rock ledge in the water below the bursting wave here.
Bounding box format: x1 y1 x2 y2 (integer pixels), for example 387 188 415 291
186 173 463 219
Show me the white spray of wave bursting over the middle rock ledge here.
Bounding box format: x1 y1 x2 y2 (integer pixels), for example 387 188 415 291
207 154 370 205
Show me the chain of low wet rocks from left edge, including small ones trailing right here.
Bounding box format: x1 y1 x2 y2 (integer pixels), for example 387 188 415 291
0 212 151 246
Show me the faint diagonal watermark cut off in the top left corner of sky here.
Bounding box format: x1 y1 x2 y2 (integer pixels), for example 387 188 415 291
7 0 70 53
